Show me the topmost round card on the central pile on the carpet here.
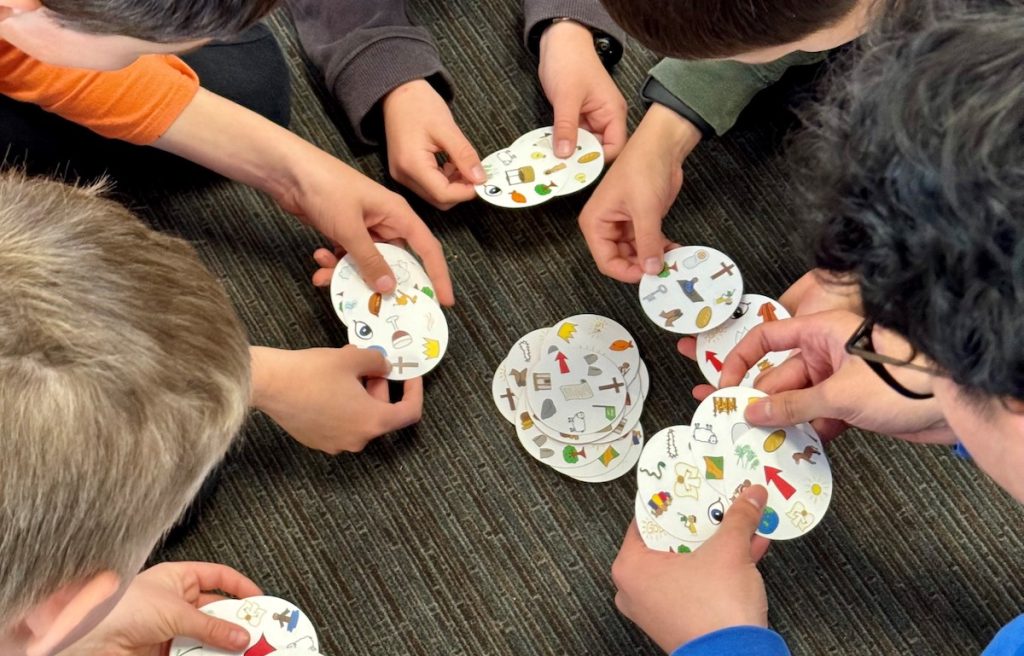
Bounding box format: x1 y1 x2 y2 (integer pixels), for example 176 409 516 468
526 345 627 435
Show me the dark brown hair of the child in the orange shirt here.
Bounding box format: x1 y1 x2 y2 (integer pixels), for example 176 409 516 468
40 0 280 43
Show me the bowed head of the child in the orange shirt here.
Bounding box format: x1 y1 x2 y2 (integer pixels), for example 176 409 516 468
0 0 278 71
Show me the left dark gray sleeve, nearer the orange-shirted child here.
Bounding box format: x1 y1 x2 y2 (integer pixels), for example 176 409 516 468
287 0 452 143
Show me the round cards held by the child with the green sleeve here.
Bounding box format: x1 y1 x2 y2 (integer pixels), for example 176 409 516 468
640 246 790 387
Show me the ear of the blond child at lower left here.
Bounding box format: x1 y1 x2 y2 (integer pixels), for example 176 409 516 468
19 572 121 656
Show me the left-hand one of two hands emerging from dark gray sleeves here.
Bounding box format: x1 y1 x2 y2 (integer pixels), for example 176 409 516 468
383 80 487 210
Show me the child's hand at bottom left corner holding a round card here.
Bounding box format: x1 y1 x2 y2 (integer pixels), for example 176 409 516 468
62 563 262 656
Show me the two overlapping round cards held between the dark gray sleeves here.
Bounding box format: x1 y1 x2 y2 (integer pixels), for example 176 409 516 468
476 127 604 208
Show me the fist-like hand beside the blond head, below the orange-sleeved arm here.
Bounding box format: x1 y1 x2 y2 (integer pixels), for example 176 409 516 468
251 346 423 454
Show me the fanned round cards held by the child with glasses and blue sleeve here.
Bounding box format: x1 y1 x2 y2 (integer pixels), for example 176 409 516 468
635 387 831 553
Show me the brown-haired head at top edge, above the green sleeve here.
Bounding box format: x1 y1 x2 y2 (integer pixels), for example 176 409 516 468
601 0 874 62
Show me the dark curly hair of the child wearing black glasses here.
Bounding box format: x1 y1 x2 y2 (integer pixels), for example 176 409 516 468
793 2 1024 398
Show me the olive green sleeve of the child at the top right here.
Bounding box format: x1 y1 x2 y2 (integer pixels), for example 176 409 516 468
650 52 828 135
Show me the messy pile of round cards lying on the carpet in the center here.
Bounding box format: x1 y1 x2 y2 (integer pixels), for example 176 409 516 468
493 314 650 483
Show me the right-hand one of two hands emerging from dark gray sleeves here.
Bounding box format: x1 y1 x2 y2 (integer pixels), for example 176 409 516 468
538 20 627 162
